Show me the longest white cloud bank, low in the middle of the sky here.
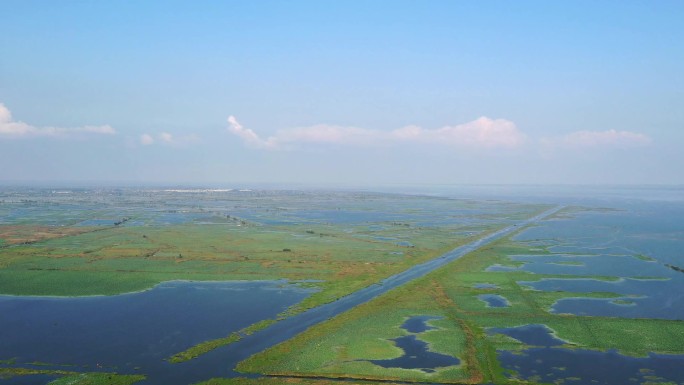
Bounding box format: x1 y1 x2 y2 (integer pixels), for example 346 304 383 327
228 116 525 149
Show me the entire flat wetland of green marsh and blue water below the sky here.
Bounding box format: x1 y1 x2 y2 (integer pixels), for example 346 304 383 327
0 184 684 384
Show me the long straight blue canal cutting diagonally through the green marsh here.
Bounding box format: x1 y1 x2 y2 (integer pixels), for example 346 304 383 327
144 206 563 385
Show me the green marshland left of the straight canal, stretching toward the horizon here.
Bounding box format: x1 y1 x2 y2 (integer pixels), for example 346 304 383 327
0 193 548 372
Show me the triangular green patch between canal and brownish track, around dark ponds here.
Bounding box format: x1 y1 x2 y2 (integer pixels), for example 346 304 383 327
239 280 467 382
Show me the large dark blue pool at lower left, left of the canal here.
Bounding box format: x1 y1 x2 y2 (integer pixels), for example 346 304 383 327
0 281 311 384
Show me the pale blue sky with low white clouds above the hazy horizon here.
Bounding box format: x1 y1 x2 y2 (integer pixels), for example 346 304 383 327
0 0 684 187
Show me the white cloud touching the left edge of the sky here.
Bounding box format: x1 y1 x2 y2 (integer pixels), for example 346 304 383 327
0 103 116 138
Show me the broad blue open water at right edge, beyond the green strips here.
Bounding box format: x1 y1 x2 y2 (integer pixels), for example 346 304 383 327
510 200 684 320
